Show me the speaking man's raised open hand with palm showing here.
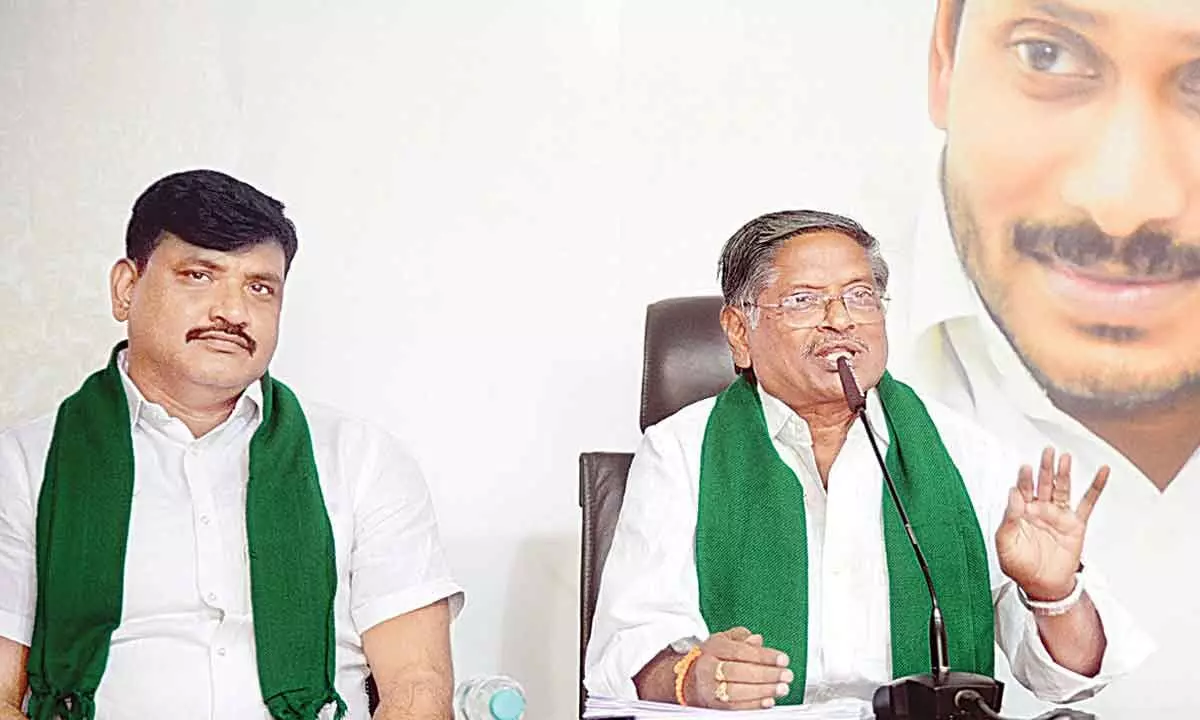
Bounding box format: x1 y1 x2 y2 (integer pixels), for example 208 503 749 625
996 448 1109 601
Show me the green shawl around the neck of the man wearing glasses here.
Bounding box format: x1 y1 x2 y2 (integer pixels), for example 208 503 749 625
696 373 995 704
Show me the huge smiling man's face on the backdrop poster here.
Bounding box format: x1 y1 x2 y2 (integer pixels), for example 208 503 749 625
930 0 1200 415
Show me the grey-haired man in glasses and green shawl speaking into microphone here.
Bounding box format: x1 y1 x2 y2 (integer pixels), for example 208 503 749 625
586 211 1147 709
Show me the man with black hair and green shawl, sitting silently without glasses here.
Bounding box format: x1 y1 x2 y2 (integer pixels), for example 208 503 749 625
0 170 462 720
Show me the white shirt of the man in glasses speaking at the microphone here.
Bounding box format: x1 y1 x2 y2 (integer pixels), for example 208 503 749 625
586 381 1147 701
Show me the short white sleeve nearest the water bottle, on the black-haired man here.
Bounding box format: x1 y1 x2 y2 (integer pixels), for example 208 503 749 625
350 432 463 634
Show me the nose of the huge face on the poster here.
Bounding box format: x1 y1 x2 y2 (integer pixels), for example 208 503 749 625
1062 89 1188 238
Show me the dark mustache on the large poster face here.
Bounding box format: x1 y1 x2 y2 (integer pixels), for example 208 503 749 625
1013 223 1200 278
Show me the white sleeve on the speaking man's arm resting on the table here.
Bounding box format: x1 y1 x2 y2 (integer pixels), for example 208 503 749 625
584 415 708 700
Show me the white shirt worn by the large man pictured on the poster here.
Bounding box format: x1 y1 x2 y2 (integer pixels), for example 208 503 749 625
888 156 1185 718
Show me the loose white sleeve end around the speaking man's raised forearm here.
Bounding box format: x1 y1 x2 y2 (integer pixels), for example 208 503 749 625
1007 570 1154 703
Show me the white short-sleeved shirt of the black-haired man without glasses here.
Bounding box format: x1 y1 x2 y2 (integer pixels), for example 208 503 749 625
0 356 462 720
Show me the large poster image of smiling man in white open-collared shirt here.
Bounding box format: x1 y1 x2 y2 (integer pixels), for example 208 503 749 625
890 0 1200 716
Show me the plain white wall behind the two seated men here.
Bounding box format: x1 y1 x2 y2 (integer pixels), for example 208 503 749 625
0 0 932 720
